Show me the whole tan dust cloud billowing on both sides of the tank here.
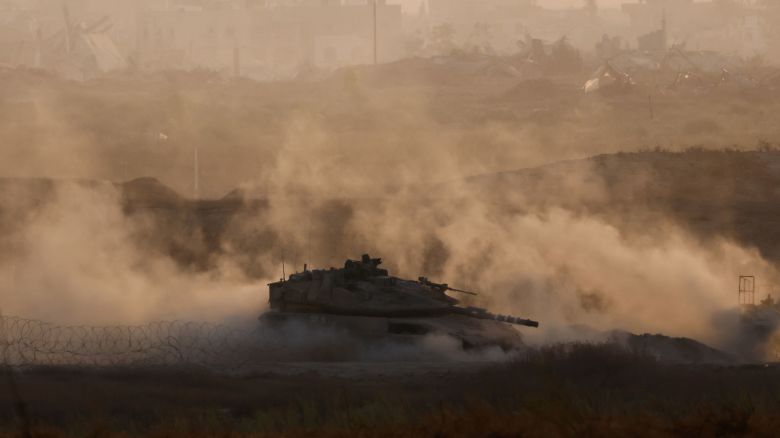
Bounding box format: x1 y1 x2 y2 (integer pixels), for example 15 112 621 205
0 82 775 354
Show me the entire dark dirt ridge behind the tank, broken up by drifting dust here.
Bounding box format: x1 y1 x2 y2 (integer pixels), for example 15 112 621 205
0 151 780 277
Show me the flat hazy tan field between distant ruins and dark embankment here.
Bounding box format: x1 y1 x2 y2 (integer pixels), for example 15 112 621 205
0 68 780 198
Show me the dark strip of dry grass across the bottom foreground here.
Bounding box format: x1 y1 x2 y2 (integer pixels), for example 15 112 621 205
0 345 780 437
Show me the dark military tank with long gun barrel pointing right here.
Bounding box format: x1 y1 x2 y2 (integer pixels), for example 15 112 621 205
261 255 539 350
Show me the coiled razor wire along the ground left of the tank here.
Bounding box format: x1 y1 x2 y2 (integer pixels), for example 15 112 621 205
0 316 274 368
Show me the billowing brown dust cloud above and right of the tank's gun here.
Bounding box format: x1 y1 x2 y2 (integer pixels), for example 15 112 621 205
247 125 776 344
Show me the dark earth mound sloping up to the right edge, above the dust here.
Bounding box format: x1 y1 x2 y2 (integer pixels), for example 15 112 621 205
468 149 780 261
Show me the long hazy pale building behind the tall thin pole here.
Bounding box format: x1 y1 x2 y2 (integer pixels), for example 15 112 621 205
137 0 403 77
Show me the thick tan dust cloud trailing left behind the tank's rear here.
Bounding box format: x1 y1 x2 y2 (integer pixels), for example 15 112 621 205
0 182 262 325
